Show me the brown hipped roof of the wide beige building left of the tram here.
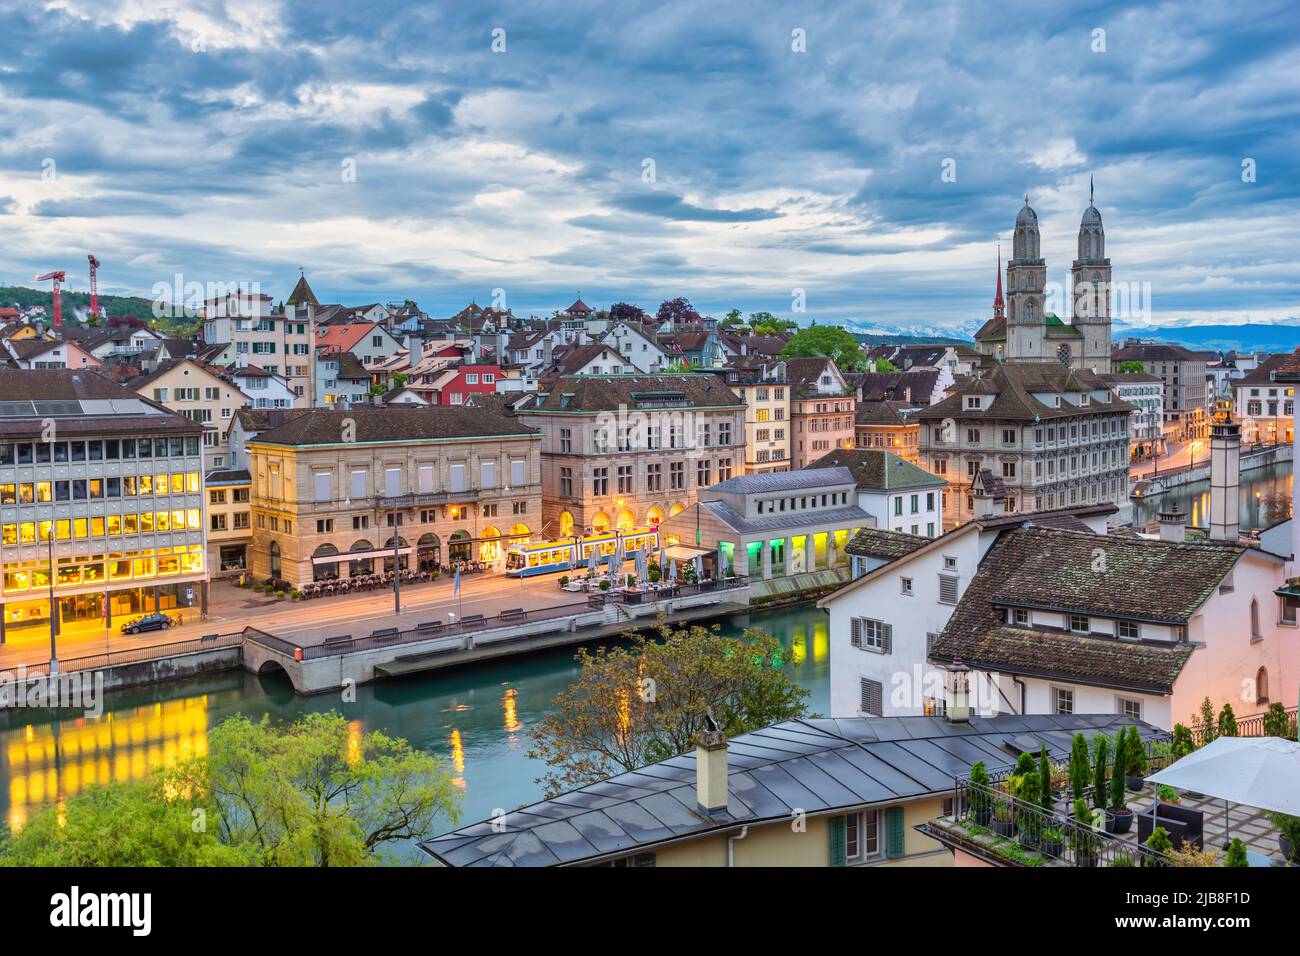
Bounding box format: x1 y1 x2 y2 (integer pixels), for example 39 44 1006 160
248 405 538 445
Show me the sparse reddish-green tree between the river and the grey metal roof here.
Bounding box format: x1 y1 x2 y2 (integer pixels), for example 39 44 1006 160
528 618 809 796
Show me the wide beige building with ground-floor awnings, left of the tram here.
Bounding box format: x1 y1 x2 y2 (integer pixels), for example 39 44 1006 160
244 406 542 585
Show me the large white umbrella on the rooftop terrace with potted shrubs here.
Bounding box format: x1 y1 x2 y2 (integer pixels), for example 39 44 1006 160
1147 737 1300 839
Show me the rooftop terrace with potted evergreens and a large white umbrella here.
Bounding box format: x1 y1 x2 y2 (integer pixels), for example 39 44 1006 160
927 734 1300 866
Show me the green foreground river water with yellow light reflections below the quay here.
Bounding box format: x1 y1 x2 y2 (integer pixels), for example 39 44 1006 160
0 605 831 842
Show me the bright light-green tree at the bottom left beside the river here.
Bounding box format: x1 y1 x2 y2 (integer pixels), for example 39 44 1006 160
0 711 460 866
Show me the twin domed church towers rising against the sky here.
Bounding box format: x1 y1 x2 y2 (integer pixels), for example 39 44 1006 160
975 183 1110 372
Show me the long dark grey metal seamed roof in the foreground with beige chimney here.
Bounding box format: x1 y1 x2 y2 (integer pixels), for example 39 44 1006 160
420 714 1160 866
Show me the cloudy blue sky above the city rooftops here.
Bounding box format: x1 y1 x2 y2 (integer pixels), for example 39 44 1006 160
0 0 1300 330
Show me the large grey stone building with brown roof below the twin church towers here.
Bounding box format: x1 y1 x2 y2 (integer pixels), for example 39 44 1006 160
917 362 1132 529
